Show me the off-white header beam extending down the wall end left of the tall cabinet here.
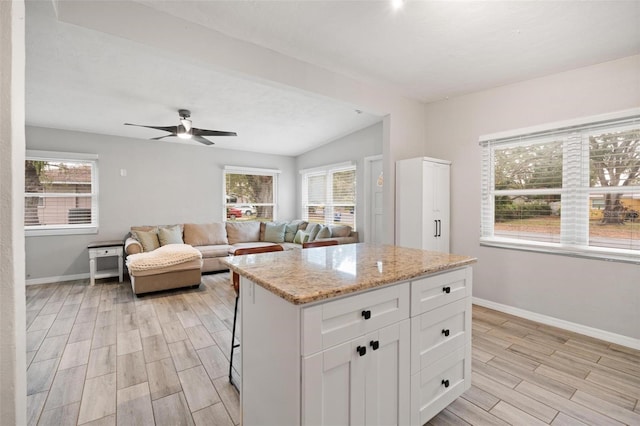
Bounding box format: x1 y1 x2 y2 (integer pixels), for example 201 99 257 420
52 2 425 243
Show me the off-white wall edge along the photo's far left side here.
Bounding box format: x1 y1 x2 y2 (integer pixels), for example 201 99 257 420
0 0 27 425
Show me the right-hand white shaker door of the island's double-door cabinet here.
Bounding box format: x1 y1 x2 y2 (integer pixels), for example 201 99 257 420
365 320 410 425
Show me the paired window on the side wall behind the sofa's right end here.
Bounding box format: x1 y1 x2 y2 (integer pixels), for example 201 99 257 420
300 163 356 230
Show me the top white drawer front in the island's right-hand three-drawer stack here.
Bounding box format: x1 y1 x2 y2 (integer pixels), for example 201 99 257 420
411 268 471 316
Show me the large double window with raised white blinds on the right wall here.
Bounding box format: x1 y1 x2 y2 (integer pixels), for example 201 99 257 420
480 110 640 262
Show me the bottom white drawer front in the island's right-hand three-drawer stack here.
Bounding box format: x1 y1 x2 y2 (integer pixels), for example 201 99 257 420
411 348 471 425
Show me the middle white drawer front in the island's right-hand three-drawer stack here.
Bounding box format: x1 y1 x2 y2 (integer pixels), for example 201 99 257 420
411 298 471 374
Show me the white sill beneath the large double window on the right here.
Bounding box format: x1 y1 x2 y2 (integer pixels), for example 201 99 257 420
480 238 640 265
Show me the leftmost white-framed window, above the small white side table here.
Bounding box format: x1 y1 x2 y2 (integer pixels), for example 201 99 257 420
24 151 98 236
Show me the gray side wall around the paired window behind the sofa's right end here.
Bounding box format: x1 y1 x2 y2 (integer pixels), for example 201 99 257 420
296 122 383 242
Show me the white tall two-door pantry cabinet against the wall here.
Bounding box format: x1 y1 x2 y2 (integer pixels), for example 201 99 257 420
396 157 451 253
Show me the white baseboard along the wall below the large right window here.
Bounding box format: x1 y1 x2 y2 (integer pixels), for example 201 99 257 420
473 297 640 350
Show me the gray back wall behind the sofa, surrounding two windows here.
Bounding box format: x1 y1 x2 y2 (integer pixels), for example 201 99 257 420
26 127 297 282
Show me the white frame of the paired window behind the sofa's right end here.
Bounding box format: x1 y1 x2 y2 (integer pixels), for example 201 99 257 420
300 161 358 231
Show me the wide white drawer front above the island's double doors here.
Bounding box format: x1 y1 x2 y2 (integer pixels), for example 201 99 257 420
302 283 409 355
